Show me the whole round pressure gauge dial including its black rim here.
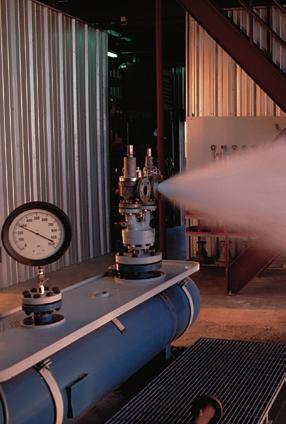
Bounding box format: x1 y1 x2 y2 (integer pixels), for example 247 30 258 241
2 202 71 266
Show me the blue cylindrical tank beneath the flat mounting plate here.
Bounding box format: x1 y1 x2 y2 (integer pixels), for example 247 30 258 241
0 279 200 424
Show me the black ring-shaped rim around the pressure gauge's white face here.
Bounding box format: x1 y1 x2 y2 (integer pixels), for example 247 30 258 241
1 201 72 266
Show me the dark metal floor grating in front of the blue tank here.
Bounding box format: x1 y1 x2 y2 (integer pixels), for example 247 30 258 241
107 338 286 424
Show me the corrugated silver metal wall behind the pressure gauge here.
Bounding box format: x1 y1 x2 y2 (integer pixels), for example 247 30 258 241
0 0 110 287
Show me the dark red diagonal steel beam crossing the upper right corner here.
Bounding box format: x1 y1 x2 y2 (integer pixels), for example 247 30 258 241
177 0 286 112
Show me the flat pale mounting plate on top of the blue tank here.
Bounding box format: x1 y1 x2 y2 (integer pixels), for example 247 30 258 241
0 260 199 382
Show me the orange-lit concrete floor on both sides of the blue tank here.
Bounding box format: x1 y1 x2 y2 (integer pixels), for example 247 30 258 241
0 255 286 346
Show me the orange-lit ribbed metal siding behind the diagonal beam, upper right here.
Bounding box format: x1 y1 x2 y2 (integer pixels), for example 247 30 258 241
186 8 286 117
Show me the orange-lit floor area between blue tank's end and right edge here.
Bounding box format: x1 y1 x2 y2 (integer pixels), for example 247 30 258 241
174 268 286 346
